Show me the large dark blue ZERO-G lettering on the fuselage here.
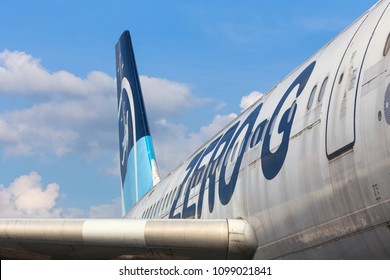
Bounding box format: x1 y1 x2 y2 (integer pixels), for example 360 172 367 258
169 62 316 218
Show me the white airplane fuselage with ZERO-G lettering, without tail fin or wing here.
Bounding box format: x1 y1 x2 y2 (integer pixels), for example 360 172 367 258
126 1 390 259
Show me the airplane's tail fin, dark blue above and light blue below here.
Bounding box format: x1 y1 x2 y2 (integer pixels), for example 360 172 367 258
115 31 160 214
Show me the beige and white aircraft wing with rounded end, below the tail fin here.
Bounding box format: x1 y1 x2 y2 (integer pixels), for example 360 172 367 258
0 219 258 259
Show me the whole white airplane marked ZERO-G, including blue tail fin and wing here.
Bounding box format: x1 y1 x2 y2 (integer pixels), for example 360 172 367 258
0 0 390 259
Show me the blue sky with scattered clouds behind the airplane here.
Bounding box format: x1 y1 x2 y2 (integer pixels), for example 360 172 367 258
0 0 376 218
